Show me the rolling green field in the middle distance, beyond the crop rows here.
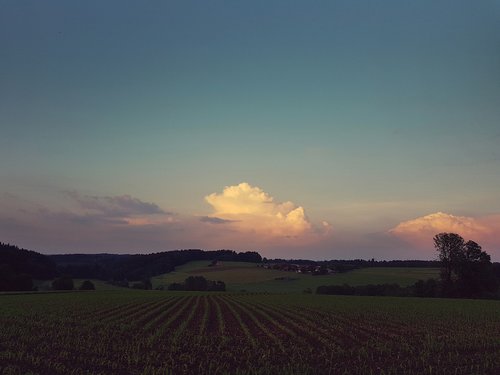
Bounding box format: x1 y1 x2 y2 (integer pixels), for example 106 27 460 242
152 261 439 293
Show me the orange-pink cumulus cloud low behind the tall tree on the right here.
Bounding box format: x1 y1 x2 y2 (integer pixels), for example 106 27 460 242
389 212 500 253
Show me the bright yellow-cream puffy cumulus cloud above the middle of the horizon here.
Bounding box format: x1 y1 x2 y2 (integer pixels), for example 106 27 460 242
205 182 312 238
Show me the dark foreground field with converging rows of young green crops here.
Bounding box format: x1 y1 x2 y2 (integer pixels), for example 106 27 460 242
0 291 500 374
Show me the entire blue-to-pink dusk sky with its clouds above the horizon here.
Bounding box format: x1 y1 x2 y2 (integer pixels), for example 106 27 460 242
0 0 500 261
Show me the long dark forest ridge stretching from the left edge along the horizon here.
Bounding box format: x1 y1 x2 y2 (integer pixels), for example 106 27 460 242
0 242 262 291
